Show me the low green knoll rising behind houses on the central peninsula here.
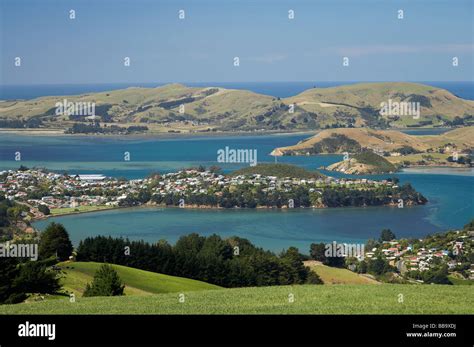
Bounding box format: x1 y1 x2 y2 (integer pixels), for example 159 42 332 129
232 164 324 178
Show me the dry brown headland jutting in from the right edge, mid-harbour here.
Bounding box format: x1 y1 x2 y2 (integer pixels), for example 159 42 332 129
271 126 474 174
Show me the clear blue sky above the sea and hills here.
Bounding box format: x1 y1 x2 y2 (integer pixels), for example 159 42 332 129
0 0 474 84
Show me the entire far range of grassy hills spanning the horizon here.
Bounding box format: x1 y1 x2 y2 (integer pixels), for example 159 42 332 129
0 83 474 132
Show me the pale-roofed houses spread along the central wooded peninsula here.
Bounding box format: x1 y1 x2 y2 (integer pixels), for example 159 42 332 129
0 169 397 218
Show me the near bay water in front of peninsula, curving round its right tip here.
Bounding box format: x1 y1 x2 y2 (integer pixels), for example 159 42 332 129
31 172 474 251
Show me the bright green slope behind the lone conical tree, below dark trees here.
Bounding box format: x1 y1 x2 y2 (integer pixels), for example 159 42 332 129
59 262 220 296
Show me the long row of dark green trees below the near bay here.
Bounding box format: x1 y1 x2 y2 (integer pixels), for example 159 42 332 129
77 234 321 287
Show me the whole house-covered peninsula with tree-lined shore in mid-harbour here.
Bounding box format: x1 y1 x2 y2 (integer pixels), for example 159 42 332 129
0 164 427 229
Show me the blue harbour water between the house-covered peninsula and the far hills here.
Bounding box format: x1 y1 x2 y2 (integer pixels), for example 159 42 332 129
0 134 341 178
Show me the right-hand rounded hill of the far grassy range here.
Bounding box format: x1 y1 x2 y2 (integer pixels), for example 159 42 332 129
285 82 474 127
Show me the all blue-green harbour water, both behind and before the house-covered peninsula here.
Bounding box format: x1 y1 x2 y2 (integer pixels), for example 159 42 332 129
9 134 468 251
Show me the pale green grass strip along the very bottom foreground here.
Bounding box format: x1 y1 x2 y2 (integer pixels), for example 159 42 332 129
0 284 474 314
